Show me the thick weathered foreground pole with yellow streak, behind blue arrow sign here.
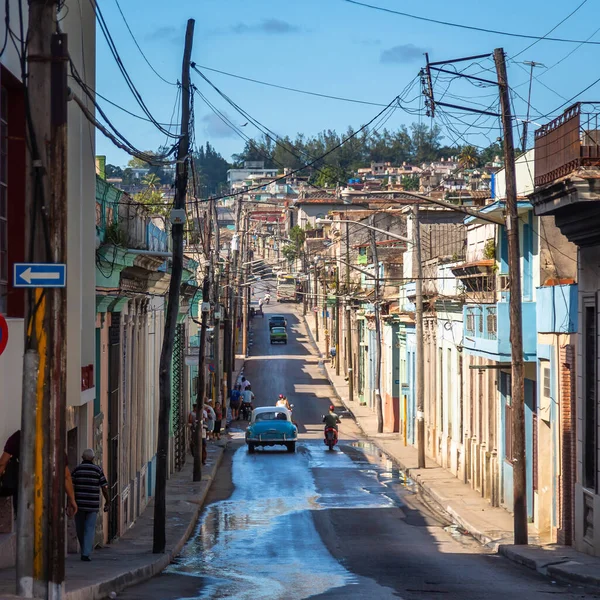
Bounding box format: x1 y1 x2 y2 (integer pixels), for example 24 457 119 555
17 0 68 600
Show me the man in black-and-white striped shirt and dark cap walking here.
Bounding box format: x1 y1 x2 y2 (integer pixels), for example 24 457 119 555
71 448 108 562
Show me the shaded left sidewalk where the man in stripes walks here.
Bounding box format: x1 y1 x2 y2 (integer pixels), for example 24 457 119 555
0 442 225 600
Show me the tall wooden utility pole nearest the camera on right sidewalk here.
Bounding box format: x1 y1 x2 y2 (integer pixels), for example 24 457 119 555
494 48 528 545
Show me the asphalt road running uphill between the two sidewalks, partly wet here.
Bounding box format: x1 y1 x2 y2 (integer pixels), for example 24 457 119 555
119 303 600 600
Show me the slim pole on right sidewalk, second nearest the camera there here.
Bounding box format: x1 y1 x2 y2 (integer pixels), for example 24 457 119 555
413 205 425 469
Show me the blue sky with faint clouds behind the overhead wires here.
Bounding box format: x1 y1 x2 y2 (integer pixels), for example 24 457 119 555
96 0 600 165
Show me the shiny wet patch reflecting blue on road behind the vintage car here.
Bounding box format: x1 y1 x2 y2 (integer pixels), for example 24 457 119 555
168 442 412 600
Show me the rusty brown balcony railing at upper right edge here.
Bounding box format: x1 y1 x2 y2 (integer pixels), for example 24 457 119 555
535 102 600 186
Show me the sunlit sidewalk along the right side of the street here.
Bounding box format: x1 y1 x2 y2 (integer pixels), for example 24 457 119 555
304 318 600 587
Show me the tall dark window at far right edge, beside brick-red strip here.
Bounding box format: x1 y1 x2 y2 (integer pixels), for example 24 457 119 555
583 301 598 492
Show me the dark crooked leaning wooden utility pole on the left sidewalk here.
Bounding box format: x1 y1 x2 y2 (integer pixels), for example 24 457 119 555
152 19 194 554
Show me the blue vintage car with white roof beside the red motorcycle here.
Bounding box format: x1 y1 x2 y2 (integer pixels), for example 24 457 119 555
246 406 298 453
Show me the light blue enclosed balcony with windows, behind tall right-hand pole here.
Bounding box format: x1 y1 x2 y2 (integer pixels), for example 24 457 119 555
463 302 537 362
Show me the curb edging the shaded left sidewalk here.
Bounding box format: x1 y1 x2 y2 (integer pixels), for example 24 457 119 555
65 446 226 600
